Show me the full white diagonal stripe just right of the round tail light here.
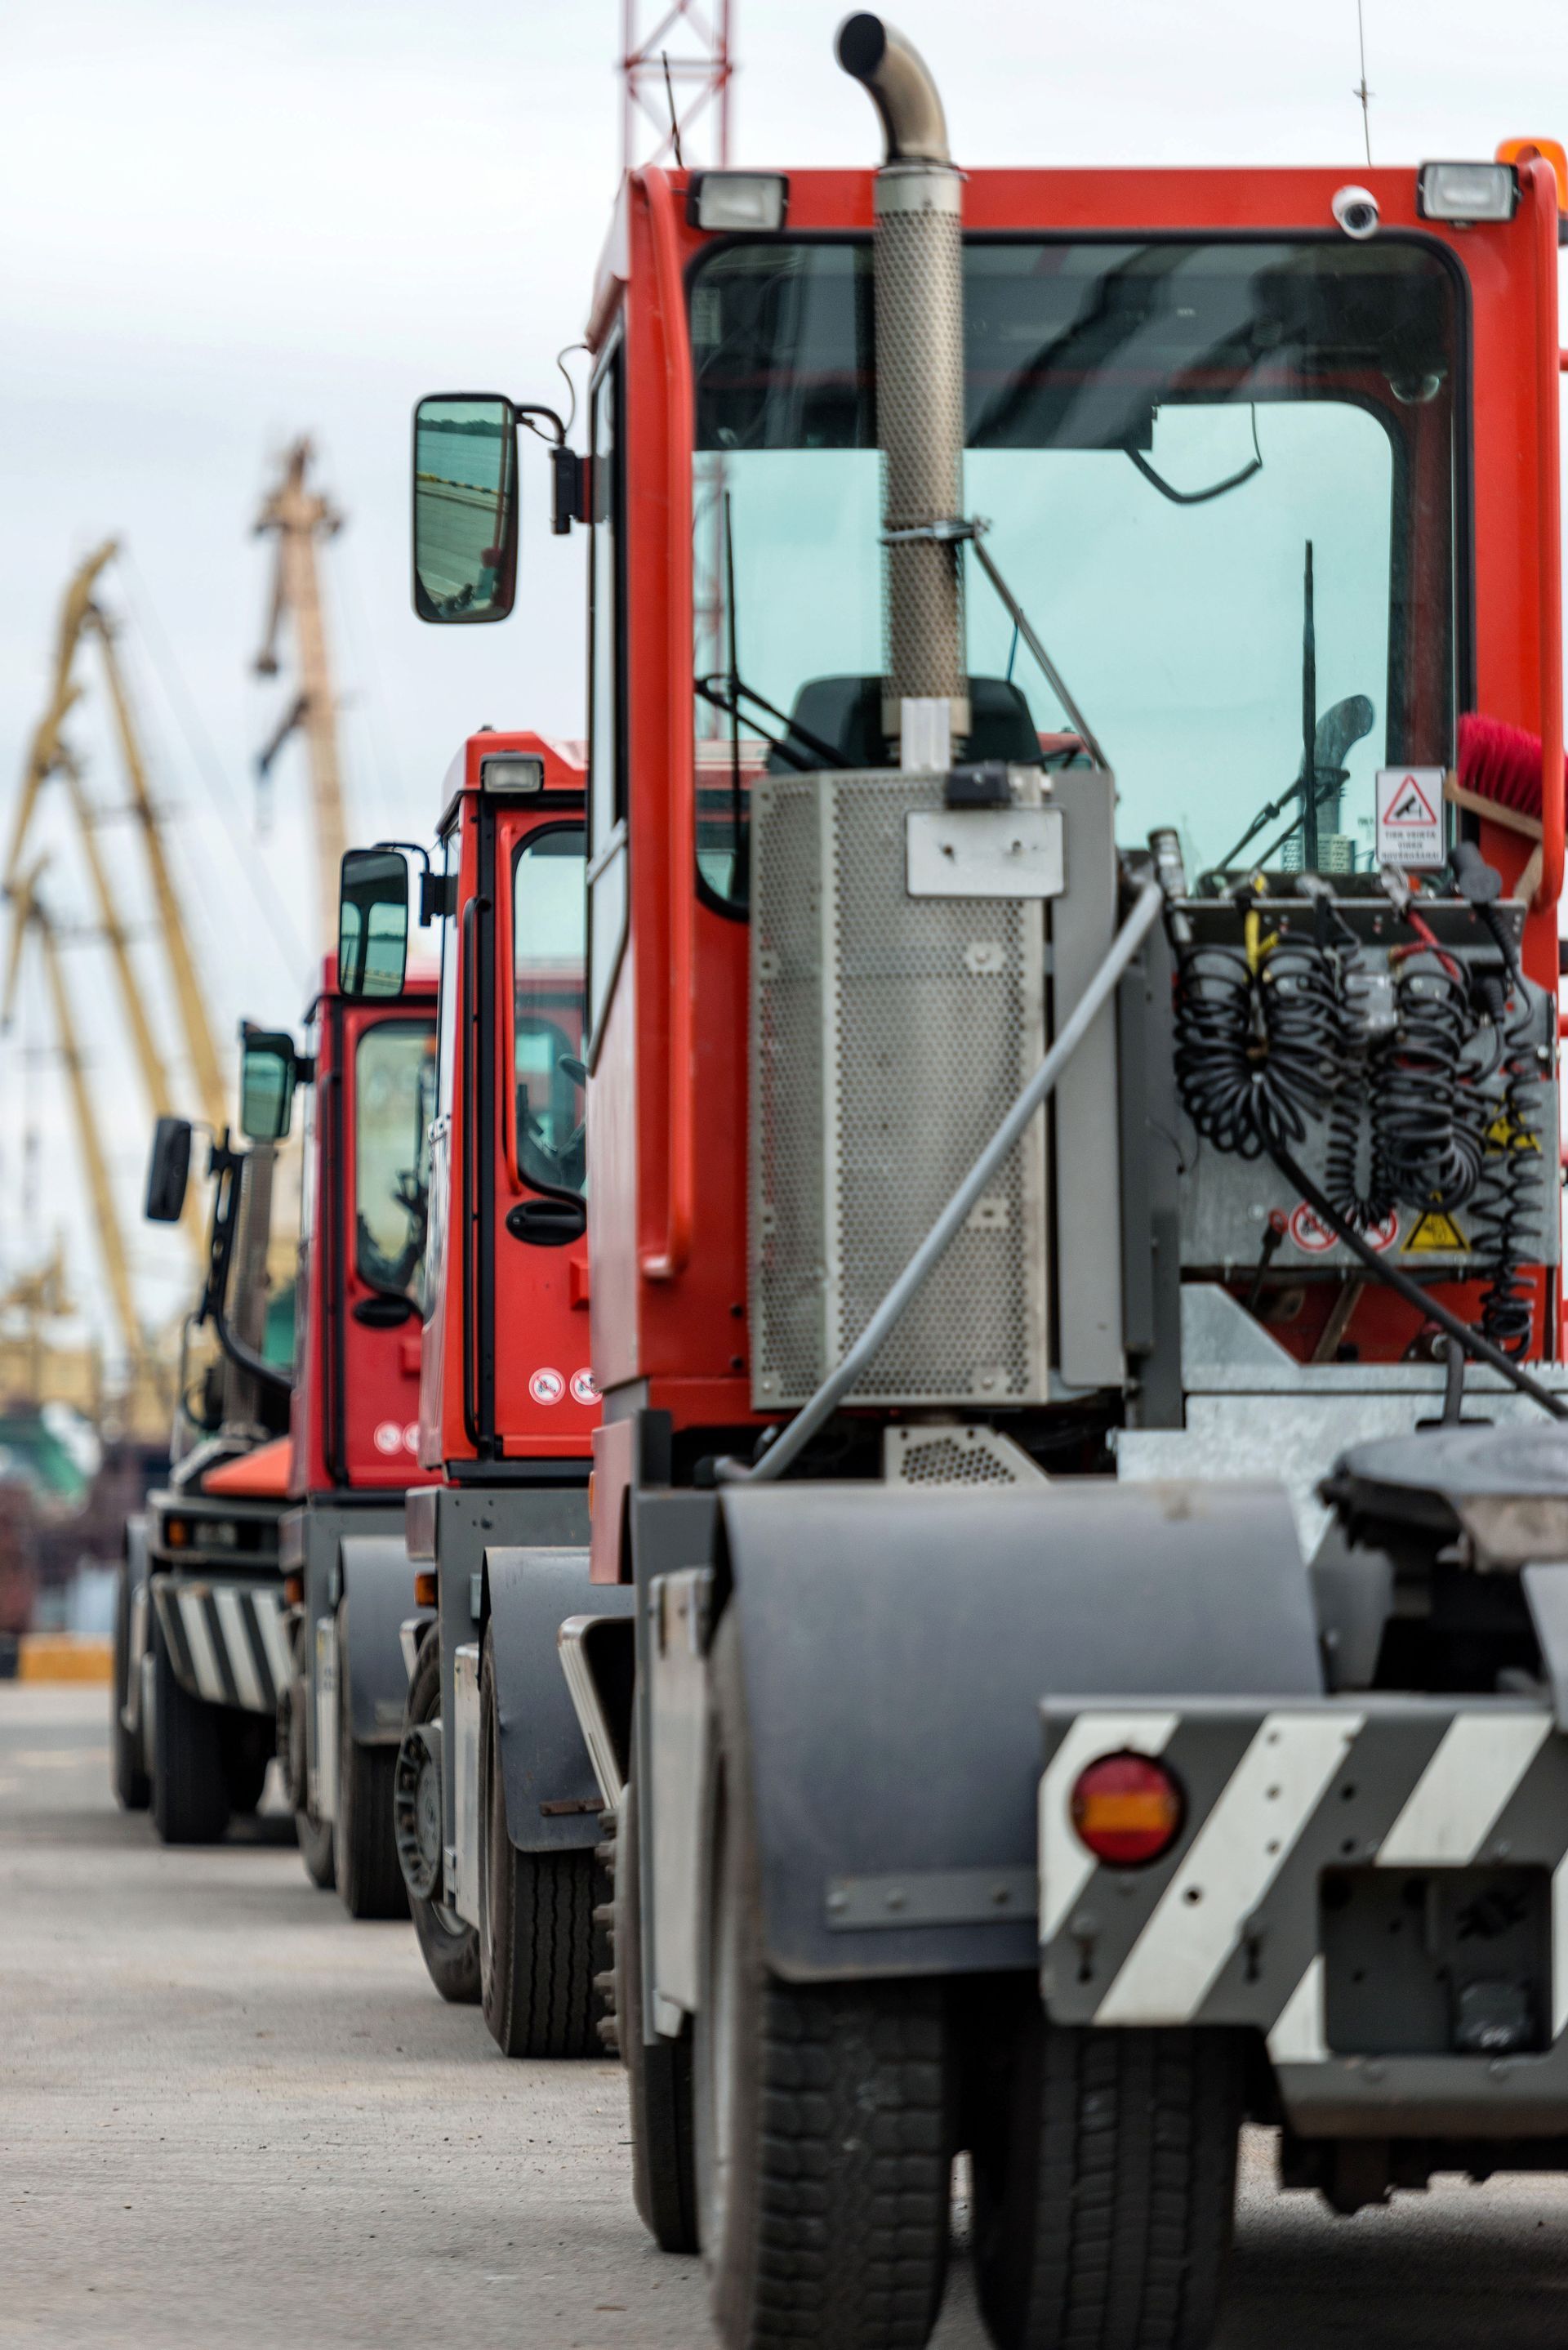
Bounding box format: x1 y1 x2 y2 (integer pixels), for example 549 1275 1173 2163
1095 1709 1364 2023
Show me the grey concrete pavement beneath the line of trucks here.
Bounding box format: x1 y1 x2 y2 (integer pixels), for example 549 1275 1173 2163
0 1683 1568 2350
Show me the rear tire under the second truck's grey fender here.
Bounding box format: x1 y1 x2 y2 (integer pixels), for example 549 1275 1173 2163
479 1638 604 2056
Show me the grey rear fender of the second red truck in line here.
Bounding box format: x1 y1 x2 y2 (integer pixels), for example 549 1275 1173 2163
484 1549 635 1852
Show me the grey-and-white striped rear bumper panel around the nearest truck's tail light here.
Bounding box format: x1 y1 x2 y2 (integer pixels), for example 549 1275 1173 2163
1039 1697 1568 2061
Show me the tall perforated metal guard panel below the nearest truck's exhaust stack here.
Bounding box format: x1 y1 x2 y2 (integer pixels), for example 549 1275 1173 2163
752 771 1046 1410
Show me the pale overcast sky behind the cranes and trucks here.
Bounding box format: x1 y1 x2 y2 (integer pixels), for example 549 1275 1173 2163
0 0 1568 1372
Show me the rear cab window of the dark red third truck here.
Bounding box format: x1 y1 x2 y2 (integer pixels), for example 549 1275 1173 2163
355 1020 435 1297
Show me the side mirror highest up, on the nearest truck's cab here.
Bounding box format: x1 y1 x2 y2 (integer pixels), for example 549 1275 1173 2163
414 392 517 625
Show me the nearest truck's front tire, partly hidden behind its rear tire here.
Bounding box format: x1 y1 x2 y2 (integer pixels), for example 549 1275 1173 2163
613 1784 696 2251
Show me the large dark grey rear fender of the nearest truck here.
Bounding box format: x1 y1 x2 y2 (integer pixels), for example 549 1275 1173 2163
705 1478 1324 2004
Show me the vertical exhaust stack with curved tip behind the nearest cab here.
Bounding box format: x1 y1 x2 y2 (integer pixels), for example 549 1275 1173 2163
837 10 969 769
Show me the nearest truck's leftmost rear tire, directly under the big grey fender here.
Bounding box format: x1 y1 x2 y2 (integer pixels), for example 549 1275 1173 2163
693 1614 952 2350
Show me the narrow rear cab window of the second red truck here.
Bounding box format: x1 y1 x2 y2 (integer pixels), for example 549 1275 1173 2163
513 825 588 1194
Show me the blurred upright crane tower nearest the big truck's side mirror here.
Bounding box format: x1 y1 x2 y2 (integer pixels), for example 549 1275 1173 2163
256 439 348 952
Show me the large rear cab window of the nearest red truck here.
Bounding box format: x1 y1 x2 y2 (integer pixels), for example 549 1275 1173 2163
691 238 1458 898
